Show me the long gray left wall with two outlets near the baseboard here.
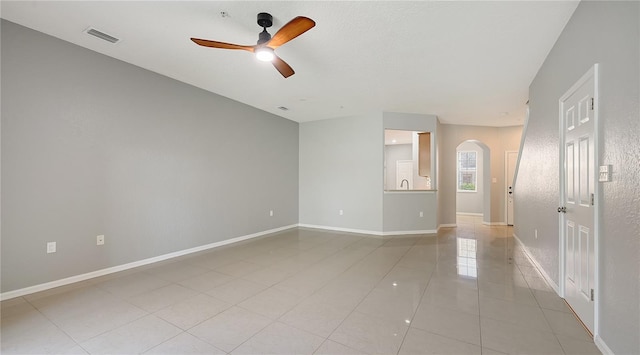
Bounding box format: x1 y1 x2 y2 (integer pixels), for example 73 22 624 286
1 21 298 292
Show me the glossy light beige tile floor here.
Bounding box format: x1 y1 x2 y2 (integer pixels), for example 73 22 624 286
0 217 599 354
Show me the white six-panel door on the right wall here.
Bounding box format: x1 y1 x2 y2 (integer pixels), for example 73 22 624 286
558 71 595 332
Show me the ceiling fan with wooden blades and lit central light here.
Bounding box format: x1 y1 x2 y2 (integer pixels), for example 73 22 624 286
191 12 316 78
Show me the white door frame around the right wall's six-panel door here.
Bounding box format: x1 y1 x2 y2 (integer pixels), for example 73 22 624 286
558 63 602 339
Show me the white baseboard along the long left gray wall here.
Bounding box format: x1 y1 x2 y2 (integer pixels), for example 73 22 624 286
0 224 297 301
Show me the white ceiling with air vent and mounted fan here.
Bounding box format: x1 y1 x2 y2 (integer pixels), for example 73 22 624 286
0 1 578 126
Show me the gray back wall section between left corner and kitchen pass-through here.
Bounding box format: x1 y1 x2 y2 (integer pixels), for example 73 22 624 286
300 113 384 232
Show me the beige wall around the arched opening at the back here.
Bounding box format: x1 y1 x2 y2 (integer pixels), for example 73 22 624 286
438 124 522 225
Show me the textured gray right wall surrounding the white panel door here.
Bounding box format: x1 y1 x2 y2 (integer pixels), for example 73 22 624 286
515 1 640 354
